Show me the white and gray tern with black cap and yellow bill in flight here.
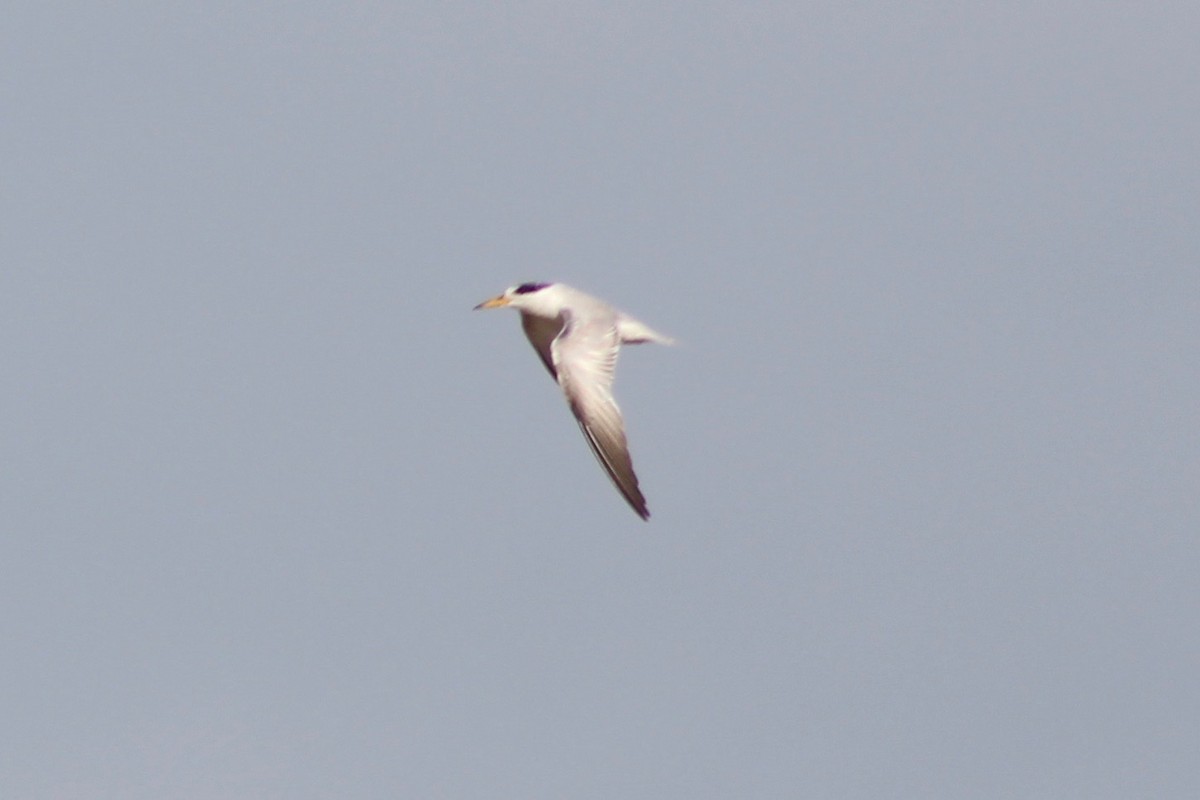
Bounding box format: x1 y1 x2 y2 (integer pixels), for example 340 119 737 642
475 283 674 519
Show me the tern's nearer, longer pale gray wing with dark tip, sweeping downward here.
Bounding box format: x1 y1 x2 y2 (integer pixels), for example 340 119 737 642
549 314 650 519
